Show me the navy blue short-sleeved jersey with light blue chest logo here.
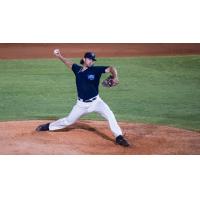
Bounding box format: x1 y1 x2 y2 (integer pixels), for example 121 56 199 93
72 64 108 100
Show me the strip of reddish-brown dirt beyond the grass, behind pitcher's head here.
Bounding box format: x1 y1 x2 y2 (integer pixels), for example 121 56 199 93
0 43 200 59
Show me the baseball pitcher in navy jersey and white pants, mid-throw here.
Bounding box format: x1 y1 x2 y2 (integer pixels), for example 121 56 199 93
36 49 129 147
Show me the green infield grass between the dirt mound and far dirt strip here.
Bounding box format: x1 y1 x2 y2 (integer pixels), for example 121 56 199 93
0 56 200 131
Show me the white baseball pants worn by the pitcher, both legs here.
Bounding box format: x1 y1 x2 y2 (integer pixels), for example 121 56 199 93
49 96 122 137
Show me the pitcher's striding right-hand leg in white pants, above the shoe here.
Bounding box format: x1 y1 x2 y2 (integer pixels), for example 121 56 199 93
95 100 122 137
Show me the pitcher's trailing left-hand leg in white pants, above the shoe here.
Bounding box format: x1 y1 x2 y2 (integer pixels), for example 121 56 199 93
49 104 85 131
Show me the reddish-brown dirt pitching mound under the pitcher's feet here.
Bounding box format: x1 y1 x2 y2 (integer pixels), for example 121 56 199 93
0 121 200 155
